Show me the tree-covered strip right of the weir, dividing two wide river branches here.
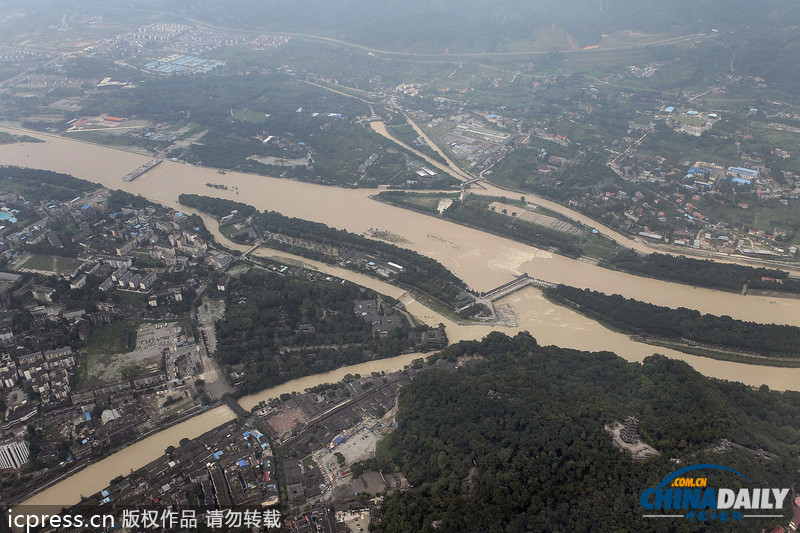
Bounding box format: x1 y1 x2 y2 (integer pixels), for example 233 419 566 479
543 285 800 366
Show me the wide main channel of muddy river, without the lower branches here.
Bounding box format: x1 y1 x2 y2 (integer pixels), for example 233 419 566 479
0 127 800 325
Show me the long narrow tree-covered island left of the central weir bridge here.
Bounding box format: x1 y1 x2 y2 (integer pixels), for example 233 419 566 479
178 194 473 312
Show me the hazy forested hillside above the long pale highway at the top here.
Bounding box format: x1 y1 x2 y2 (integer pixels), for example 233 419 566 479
142 0 800 53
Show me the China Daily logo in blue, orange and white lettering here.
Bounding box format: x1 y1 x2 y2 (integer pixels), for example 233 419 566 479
640 464 790 523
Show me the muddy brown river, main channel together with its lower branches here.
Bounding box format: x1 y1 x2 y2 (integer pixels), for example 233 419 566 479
0 127 800 504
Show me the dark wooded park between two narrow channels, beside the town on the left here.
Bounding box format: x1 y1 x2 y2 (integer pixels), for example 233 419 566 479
216 270 427 396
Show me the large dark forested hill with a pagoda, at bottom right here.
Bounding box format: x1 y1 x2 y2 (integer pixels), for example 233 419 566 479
378 333 800 533
